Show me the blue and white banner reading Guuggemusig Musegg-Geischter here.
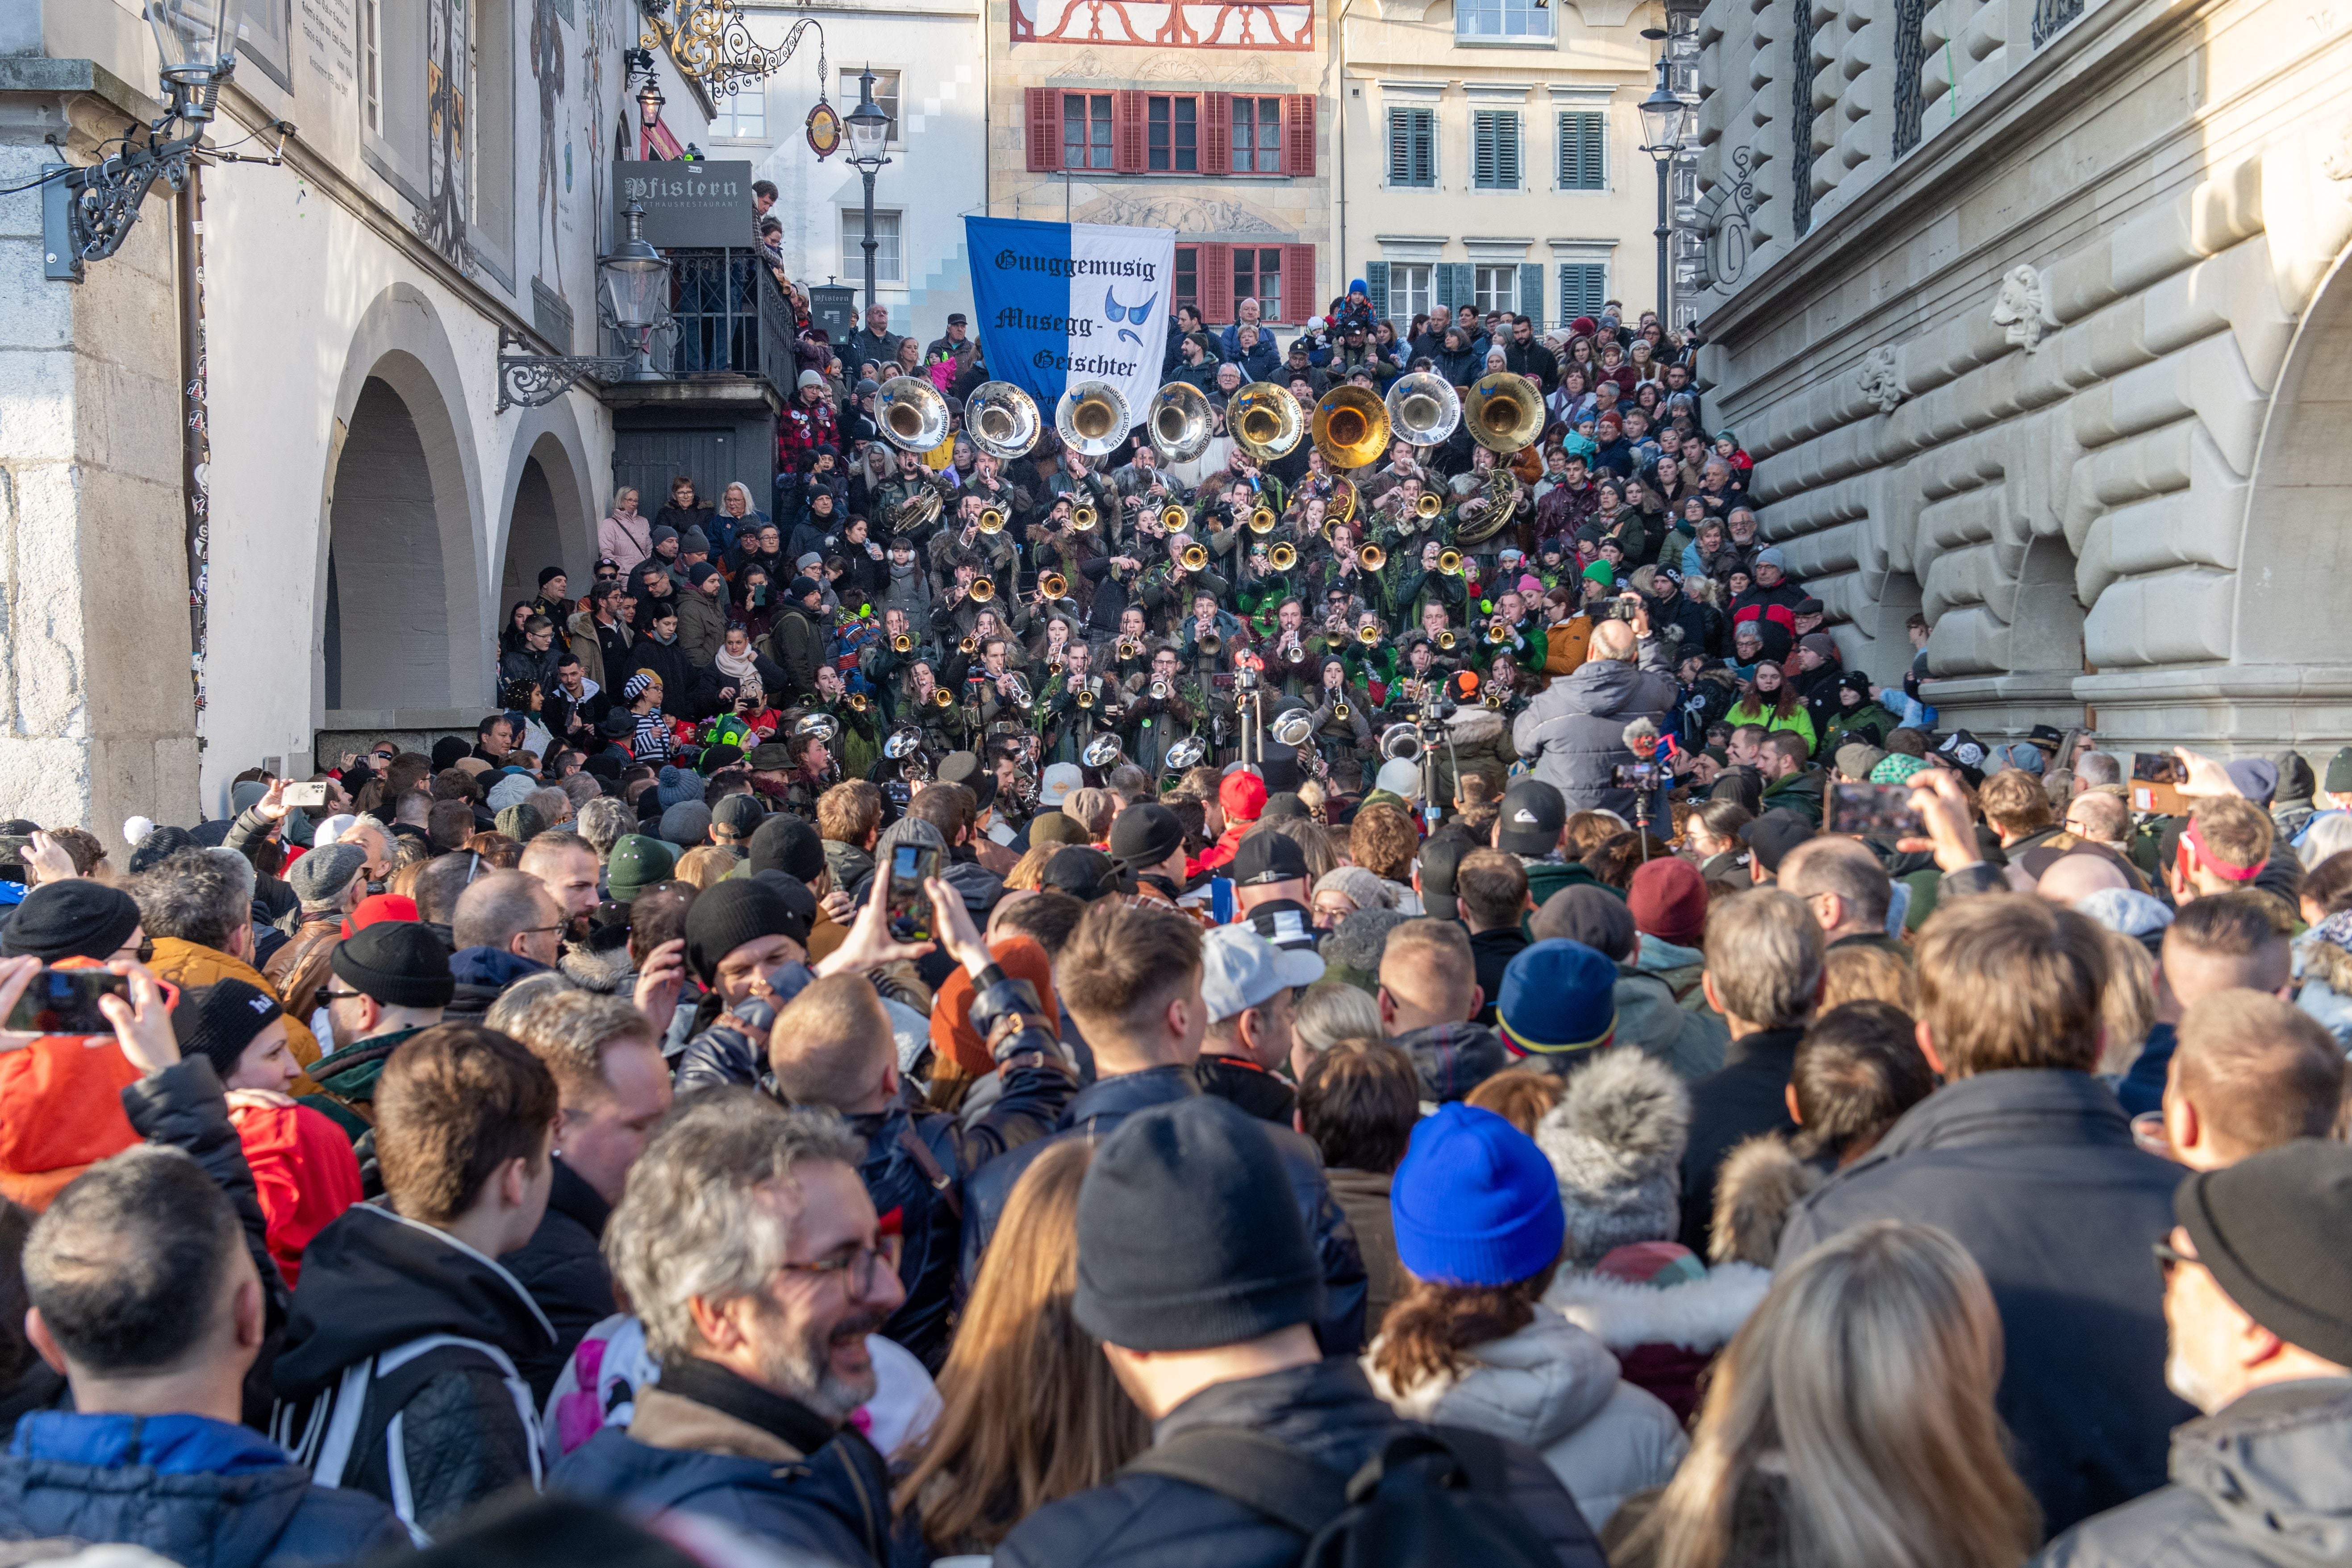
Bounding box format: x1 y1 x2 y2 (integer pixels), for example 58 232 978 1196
964 219 1176 428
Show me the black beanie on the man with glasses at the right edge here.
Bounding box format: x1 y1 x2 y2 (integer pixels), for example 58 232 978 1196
2173 1138 2352 1366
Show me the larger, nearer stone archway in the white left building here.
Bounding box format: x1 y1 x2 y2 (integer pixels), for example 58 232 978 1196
313 284 489 726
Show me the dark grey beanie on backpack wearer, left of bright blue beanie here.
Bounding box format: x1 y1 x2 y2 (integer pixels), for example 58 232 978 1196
1070 1096 1324 1349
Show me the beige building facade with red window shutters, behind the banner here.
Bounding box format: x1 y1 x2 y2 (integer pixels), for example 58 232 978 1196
978 0 1348 331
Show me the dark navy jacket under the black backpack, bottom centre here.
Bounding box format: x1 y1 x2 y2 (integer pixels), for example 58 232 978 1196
995 1356 1604 1568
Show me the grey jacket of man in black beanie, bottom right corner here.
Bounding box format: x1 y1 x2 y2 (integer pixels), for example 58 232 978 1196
2035 1378 2352 1568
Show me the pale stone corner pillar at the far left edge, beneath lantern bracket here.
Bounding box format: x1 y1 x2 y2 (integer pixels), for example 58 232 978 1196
0 56 200 858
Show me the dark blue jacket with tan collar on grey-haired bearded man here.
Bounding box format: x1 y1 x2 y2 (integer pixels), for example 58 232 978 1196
548 1359 889 1563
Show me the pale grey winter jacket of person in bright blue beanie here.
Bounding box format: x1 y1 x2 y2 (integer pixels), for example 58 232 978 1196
1364 1307 1691 1530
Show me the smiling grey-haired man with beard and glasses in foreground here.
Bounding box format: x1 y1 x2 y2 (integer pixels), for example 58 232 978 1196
548 1091 905 1563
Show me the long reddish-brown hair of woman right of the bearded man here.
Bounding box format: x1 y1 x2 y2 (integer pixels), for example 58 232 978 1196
892 1143 1152 1563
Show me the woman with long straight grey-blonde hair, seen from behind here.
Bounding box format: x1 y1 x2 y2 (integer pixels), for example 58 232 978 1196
1604 1220 2042 1568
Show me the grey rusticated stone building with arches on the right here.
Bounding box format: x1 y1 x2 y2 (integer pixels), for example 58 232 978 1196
1691 0 2352 750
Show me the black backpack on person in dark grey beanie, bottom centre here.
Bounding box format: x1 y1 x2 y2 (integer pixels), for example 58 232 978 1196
1124 1427 1557 1568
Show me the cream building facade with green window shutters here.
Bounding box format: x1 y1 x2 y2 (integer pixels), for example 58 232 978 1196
1334 0 1660 331
